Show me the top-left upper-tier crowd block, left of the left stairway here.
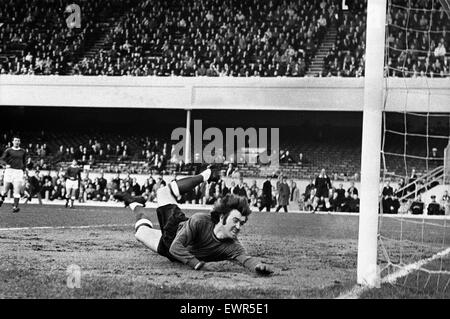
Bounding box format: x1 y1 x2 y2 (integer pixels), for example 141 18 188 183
0 0 120 75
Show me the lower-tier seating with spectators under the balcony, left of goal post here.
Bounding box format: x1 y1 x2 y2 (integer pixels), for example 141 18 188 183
0 125 366 180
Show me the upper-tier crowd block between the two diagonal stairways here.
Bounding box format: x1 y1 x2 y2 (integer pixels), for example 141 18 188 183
75 0 339 77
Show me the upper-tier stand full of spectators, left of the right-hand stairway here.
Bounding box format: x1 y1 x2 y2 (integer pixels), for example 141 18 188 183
0 0 339 76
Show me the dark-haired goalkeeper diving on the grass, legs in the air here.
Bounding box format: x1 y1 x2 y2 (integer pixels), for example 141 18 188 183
114 167 273 276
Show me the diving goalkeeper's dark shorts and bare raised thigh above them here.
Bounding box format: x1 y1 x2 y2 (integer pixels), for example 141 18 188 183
156 184 188 261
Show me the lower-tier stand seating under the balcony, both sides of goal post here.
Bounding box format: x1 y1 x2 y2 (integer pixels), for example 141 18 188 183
0 121 446 180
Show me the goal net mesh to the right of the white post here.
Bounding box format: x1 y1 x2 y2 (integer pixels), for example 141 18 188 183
378 0 450 297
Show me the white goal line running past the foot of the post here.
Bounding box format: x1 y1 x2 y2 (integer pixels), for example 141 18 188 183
336 248 450 299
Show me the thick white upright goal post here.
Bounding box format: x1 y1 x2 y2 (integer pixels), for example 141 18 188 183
357 0 387 287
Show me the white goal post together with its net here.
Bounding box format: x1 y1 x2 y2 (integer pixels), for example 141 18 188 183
358 0 450 297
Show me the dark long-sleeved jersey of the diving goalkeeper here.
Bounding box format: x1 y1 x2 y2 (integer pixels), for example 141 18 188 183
170 213 259 270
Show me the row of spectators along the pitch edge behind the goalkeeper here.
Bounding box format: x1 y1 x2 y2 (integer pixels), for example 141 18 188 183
1 132 450 215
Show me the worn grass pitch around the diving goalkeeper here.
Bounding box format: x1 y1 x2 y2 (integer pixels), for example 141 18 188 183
0 205 450 299
